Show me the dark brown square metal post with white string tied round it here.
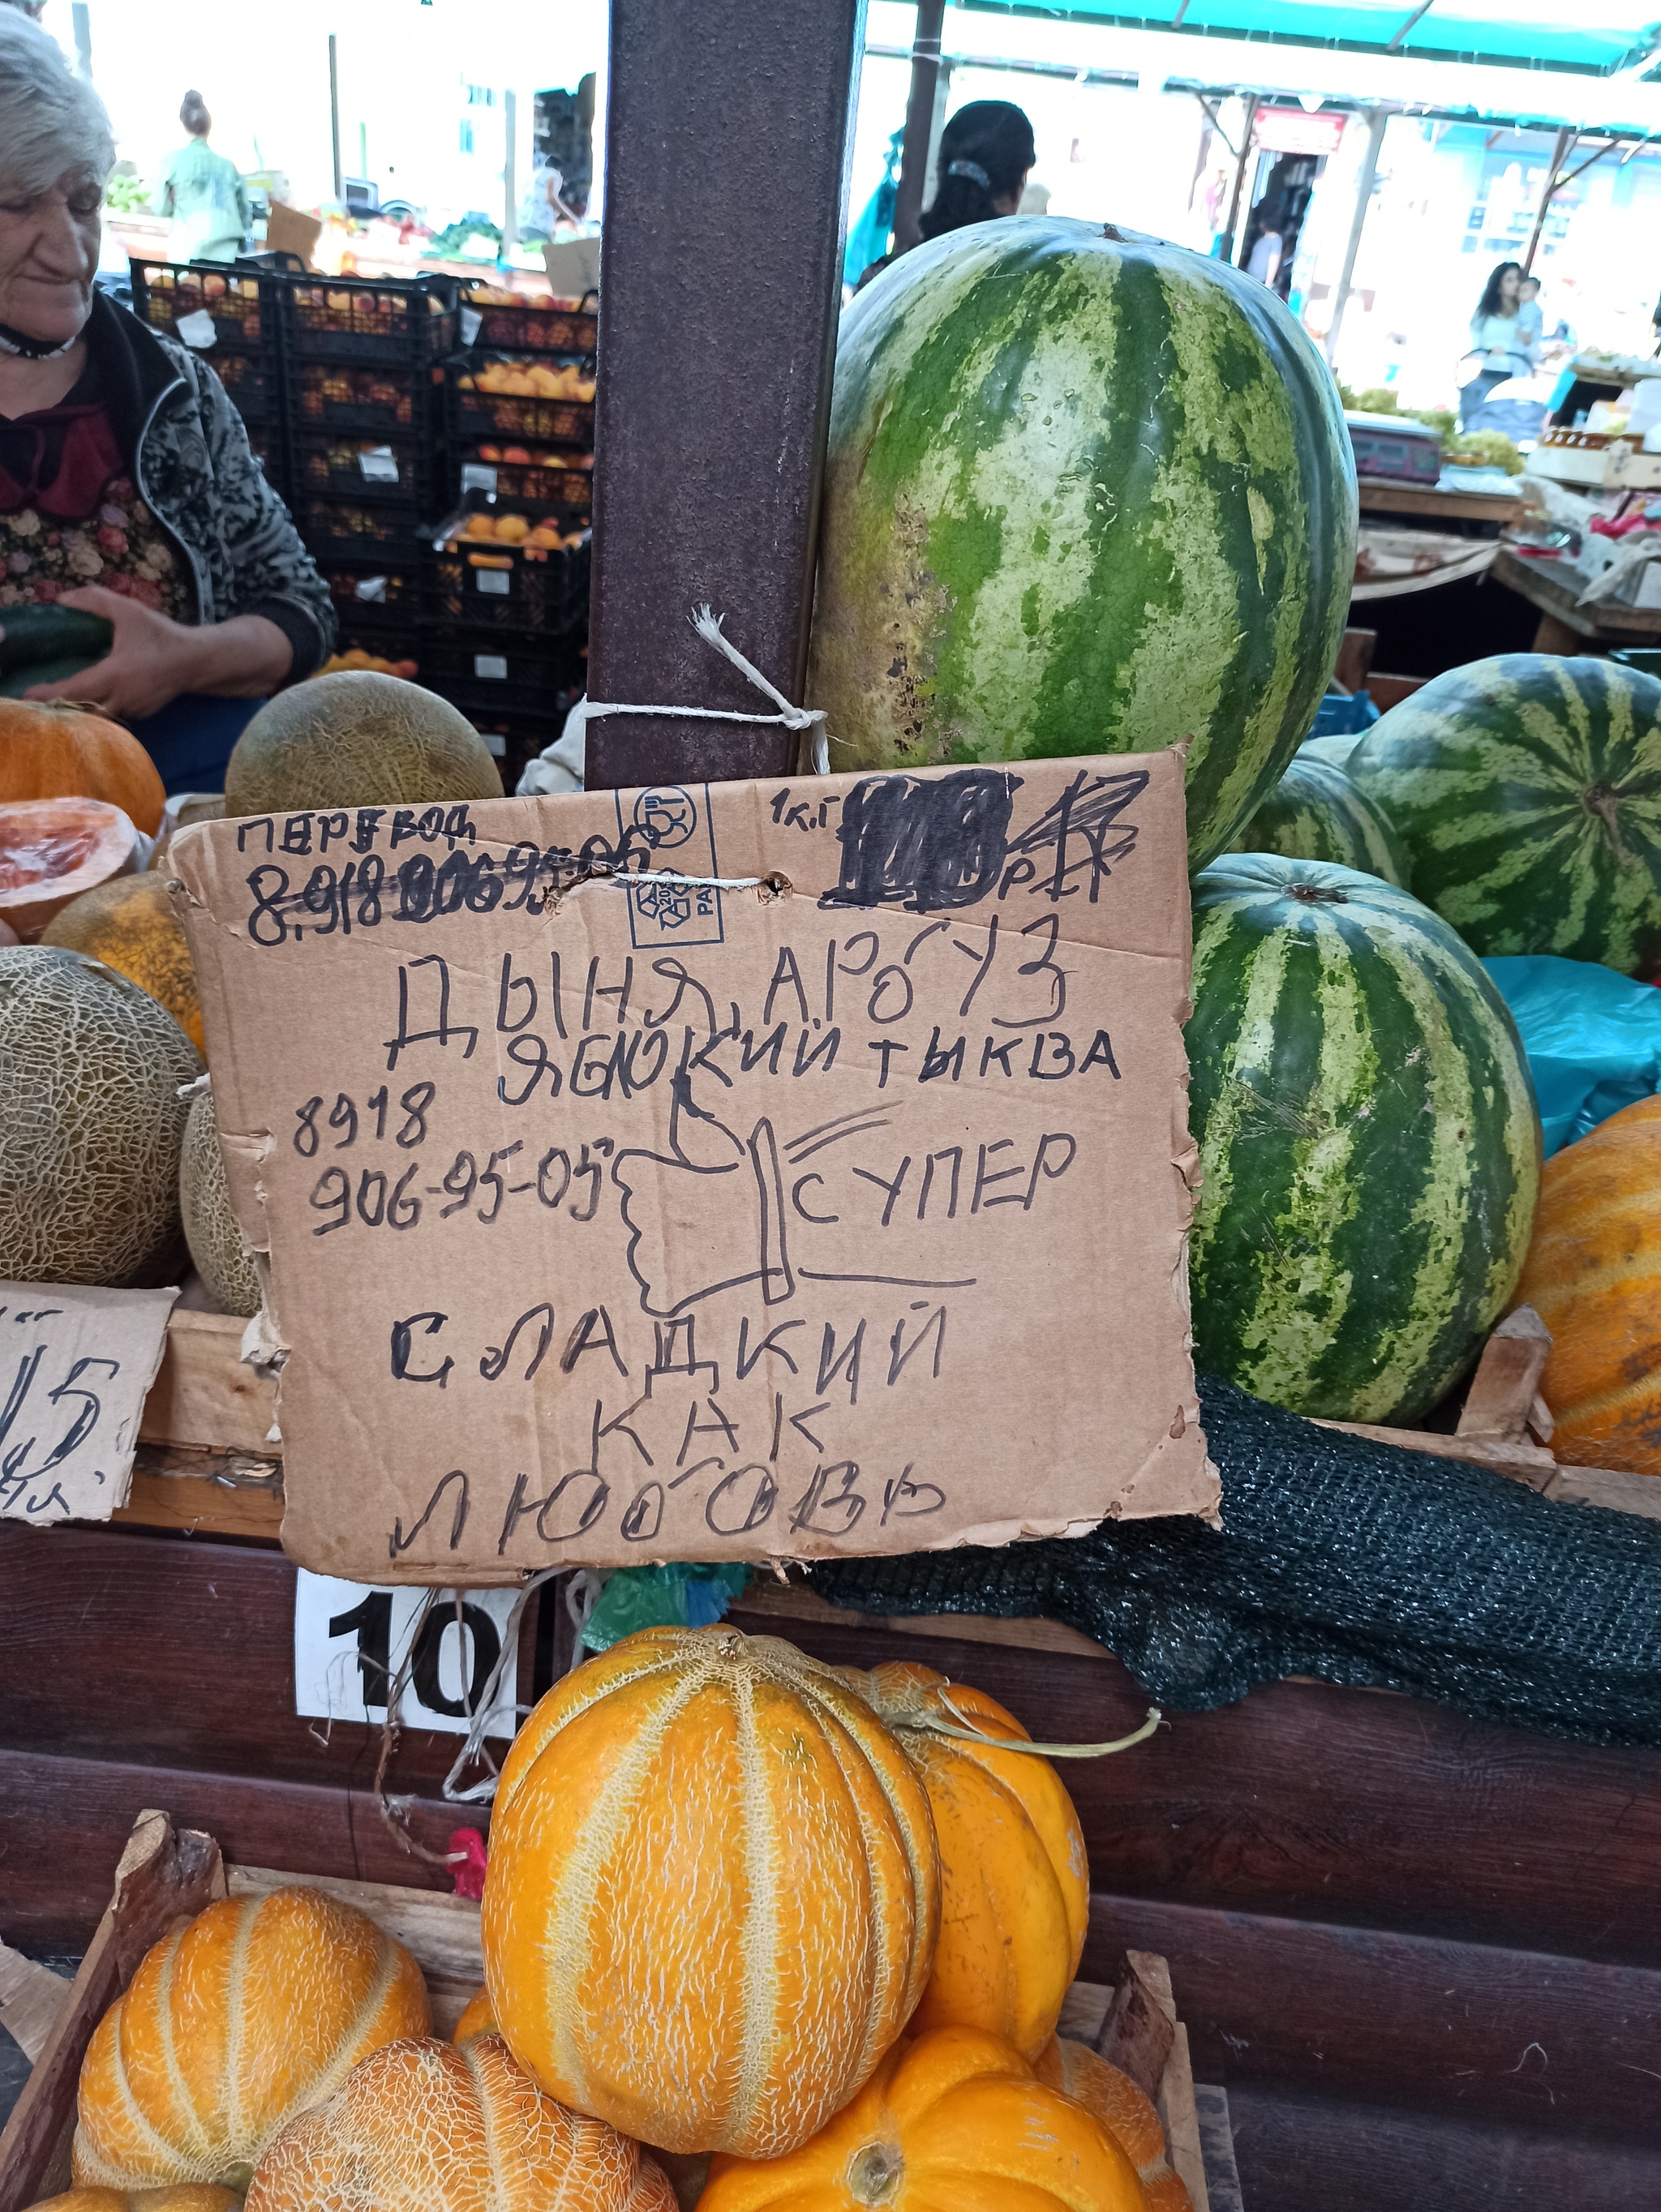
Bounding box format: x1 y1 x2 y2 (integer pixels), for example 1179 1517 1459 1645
588 0 865 790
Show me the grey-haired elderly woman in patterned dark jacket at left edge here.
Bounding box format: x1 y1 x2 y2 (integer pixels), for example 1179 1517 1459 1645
0 6 334 790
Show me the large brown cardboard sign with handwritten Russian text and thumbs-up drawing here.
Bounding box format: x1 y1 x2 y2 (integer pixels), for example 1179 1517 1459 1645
170 752 1217 1586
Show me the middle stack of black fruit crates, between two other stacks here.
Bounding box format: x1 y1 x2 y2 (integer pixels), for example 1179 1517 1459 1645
274 274 456 681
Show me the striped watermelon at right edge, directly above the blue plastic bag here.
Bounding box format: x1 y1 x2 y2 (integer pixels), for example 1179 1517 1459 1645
1347 653 1661 975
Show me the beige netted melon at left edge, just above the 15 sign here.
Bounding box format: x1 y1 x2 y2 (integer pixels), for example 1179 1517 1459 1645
0 945 201 1288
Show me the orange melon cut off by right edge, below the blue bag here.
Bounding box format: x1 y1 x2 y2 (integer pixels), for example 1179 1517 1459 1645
1517 1097 1661 1476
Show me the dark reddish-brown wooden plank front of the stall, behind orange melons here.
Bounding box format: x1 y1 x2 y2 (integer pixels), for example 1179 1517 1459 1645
0 1522 1661 2212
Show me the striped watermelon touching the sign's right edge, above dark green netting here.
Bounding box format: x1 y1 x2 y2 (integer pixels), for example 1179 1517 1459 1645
1187 854 1539 1422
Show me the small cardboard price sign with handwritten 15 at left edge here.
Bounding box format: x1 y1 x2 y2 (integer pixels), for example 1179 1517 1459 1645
0 1283 179 1526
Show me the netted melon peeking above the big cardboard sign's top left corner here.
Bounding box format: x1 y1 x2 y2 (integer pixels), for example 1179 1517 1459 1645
225 671 502 814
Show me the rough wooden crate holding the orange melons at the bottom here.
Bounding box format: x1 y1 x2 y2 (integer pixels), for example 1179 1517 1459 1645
0 1811 1210 2212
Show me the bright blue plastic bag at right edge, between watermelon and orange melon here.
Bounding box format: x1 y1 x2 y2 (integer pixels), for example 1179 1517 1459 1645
1482 954 1661 1159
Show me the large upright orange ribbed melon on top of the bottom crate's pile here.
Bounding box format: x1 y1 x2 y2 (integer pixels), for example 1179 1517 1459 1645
482 1628 940 2157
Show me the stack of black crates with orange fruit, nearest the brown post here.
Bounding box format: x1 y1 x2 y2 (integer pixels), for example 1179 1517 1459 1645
436 292 595 790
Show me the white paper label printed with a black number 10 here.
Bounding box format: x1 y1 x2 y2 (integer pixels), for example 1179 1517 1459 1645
294 1568 520 1736
